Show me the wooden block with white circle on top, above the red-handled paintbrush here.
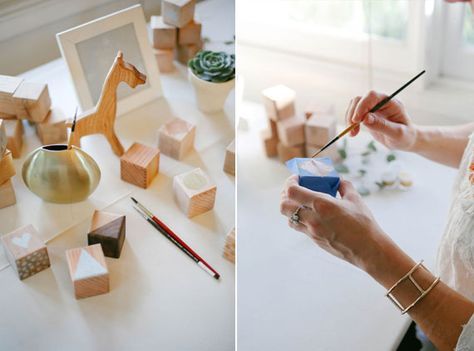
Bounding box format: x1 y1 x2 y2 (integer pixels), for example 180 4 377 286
173 168 217 218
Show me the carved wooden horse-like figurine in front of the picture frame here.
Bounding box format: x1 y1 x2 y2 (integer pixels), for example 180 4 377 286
69 51 146 156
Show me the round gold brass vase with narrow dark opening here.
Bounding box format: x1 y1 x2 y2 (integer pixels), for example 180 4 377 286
22 144 100 204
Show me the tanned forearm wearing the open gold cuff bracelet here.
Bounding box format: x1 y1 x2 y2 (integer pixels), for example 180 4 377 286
365 237 474 351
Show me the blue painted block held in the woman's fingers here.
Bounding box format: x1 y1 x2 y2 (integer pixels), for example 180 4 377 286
286 157 340 197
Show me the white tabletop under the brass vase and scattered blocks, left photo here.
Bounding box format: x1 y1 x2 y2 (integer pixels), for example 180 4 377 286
0 1 235 351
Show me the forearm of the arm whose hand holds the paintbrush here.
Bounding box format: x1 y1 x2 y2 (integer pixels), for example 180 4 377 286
410 123 474 168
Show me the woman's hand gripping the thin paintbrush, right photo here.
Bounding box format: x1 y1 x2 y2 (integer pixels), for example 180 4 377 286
346 91 417 151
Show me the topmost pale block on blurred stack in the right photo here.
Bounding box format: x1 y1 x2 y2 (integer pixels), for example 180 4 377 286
262 85 296 121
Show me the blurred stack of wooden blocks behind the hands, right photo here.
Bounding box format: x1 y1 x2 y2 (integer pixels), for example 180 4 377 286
262 85 338 162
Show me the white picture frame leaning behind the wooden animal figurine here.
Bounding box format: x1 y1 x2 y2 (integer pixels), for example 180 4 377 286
56 4 163 115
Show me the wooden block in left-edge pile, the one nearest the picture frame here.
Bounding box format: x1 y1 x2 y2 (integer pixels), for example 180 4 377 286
13 81 51 122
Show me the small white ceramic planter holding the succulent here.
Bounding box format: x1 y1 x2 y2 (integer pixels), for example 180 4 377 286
188 68 235 113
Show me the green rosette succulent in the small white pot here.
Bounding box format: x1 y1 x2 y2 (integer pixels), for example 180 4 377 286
188 51 235 83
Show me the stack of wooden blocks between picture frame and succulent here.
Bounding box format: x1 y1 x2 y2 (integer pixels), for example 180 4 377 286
150 0 203 73
